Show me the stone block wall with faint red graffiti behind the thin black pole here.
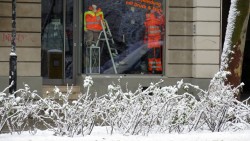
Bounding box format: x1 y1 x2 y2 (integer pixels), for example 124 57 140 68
0 0 42 93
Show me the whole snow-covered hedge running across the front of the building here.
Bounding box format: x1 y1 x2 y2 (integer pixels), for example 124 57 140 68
0 72 250 137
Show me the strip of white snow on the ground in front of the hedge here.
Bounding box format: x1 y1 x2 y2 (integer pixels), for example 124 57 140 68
0 127 250 141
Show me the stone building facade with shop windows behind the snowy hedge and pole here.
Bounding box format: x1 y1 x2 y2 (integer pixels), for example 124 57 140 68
0 0 242 98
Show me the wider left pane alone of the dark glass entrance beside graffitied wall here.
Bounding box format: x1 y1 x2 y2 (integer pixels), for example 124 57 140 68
42 0 64 79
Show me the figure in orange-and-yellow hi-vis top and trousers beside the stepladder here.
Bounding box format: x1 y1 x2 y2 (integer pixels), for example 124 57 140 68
84 4 104 44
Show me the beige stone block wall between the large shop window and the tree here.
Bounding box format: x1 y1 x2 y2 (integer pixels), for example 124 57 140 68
166 0 221 78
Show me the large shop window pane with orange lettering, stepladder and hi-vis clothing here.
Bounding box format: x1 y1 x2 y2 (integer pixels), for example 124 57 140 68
82 0 166 74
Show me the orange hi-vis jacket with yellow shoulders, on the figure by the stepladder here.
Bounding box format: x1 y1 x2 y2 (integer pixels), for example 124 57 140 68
84 8 104 31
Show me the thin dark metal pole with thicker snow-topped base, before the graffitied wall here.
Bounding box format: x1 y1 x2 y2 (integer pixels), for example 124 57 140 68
9 0 17 94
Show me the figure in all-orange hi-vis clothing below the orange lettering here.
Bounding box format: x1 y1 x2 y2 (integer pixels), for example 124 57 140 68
144 10 164 73
